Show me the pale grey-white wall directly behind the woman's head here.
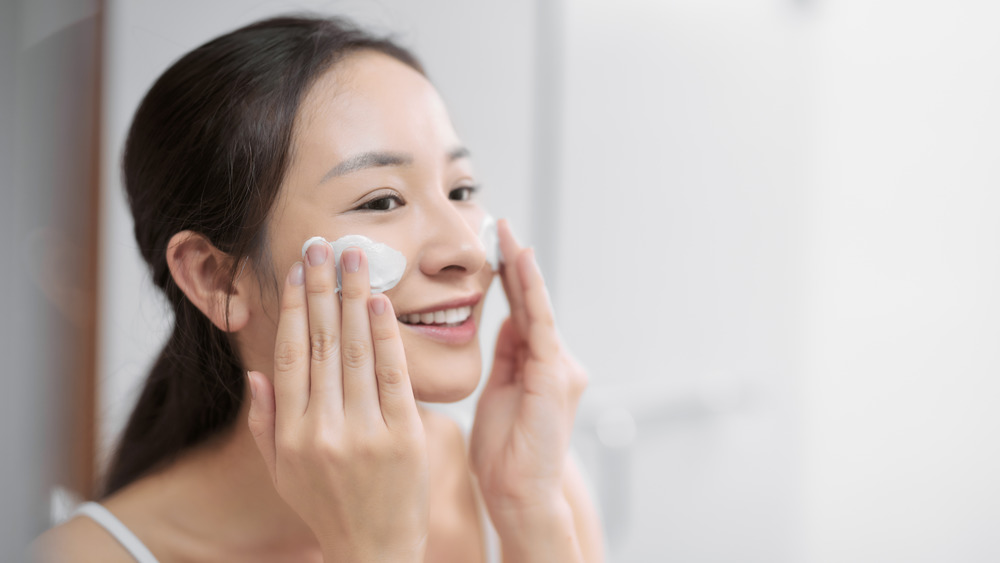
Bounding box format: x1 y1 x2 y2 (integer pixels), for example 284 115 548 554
98 0 534 463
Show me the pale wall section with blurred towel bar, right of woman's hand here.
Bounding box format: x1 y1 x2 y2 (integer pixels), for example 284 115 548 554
553 0 812 563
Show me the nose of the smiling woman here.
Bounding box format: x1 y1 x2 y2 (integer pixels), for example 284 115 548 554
419 200 486 276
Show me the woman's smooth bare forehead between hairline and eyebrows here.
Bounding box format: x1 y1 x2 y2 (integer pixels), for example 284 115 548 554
295 51 458 162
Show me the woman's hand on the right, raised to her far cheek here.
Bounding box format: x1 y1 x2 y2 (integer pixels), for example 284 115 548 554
469 220 587 529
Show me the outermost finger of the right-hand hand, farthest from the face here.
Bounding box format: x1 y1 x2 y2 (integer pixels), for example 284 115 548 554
518 248 559 362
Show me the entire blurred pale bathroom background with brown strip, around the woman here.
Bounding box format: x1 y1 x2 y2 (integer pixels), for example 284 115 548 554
0 0 1000 563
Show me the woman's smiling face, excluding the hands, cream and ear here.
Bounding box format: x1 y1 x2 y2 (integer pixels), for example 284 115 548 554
240 51 493 401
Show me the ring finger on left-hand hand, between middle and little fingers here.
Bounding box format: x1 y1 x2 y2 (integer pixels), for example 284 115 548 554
340 246 382 420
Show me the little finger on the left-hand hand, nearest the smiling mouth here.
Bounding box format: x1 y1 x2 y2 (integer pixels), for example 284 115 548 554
368 295 419 428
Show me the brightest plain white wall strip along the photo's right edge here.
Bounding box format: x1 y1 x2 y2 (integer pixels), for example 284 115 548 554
802 0 1000 563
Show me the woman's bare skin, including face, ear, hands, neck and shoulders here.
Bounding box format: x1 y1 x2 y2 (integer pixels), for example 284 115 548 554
35 52 603 561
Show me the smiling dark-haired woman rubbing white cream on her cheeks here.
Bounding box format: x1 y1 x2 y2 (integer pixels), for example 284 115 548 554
36 14 602 562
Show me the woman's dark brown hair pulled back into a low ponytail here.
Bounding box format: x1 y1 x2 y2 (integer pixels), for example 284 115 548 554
103 16 423 496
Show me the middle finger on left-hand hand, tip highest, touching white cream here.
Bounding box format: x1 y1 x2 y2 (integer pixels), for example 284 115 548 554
305 239 344 416
